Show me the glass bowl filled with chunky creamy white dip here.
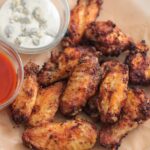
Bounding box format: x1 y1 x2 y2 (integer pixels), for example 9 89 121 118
0 0 70 54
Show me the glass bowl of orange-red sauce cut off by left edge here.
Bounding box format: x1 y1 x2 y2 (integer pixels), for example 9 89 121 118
0 40 24 110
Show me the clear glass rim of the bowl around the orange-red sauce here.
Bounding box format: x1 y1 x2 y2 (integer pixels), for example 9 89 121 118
0 39 24 110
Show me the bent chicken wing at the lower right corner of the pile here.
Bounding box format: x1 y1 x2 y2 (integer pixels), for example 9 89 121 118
100 89 150 150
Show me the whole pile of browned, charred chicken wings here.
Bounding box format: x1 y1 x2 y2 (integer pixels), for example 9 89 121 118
10 0 150 150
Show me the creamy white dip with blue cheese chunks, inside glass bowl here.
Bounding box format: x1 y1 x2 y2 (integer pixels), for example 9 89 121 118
0 0 60 48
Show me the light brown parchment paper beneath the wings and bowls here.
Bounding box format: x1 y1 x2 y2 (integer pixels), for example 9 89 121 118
0 0 150 150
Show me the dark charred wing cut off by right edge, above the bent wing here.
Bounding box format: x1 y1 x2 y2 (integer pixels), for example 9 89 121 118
125 43 150 85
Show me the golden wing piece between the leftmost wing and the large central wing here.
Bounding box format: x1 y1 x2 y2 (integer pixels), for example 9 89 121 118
28 82 64 127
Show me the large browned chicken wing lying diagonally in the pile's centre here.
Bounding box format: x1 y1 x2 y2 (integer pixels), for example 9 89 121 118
60 55 101 116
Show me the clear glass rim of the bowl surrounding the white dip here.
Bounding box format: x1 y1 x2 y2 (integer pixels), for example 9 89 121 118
0 0 70 54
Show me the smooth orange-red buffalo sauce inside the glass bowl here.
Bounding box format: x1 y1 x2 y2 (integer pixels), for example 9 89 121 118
0 53 17 104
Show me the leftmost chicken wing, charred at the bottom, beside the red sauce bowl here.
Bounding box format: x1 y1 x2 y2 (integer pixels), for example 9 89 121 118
10 62 39 124
